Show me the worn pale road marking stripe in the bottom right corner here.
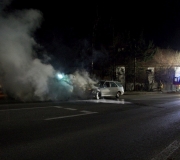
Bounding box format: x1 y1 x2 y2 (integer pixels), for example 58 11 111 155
151 140 180 160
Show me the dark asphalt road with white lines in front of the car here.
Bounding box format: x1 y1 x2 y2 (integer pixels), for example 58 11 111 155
0 93 180 160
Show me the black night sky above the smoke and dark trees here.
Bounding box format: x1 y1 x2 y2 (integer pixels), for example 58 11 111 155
2 0 180 71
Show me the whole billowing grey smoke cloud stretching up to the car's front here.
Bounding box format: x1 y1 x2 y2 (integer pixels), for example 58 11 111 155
0 1 95 101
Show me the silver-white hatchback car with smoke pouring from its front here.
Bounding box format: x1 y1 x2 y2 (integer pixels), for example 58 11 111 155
91 80 124 99
